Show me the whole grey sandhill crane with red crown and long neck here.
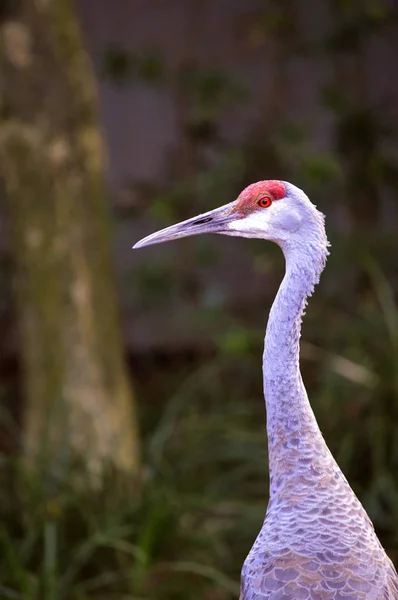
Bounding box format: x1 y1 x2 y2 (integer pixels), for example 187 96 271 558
134 180 398 600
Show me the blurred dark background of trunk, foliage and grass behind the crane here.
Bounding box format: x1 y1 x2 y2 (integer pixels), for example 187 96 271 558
0 0 398 600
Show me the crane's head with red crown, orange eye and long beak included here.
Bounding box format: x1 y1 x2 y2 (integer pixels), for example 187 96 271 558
133 180 326 248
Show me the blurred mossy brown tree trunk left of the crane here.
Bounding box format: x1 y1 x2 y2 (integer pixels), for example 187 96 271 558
0 0 139 473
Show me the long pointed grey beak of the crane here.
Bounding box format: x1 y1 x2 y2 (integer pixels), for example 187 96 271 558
133 201 236 249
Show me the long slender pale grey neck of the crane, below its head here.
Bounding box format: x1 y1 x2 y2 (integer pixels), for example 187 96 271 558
263 220 340 499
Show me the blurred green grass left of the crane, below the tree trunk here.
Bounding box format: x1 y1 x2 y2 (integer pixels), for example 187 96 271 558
0 358 267 600
